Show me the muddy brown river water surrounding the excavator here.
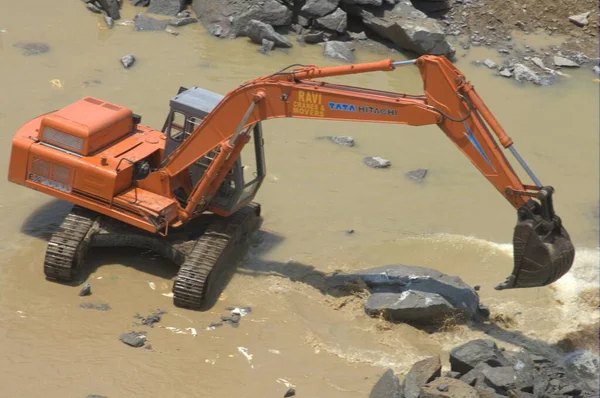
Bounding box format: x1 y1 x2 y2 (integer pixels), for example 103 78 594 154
0 0 599 397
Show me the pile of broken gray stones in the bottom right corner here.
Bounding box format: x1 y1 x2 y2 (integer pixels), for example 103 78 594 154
370 339 598 398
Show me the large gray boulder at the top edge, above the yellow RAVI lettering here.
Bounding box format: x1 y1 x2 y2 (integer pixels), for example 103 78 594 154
192 0 292 38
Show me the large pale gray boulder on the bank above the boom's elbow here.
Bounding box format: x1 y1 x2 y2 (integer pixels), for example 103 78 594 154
347 0 456 58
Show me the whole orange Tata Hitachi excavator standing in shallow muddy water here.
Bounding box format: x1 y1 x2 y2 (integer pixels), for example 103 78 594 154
8 55 575 309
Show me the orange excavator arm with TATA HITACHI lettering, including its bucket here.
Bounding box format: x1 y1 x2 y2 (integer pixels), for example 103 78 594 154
154 56 575 290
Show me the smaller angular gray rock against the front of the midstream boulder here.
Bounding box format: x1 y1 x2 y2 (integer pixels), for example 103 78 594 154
365 290 457 325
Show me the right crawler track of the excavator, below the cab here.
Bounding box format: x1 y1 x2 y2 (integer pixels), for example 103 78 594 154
173 203 260 309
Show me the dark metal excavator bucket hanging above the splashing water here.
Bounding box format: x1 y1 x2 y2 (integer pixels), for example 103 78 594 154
496 195 575 290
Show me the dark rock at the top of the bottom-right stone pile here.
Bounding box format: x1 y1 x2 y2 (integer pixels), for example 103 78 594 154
450 339 510 374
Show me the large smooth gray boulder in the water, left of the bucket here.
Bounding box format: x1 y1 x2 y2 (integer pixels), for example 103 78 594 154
328 265 480 320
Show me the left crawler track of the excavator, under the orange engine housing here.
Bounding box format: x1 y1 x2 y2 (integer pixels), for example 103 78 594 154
44 206 97 282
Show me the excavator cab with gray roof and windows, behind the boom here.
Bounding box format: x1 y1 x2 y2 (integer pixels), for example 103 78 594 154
162 87 266 214
